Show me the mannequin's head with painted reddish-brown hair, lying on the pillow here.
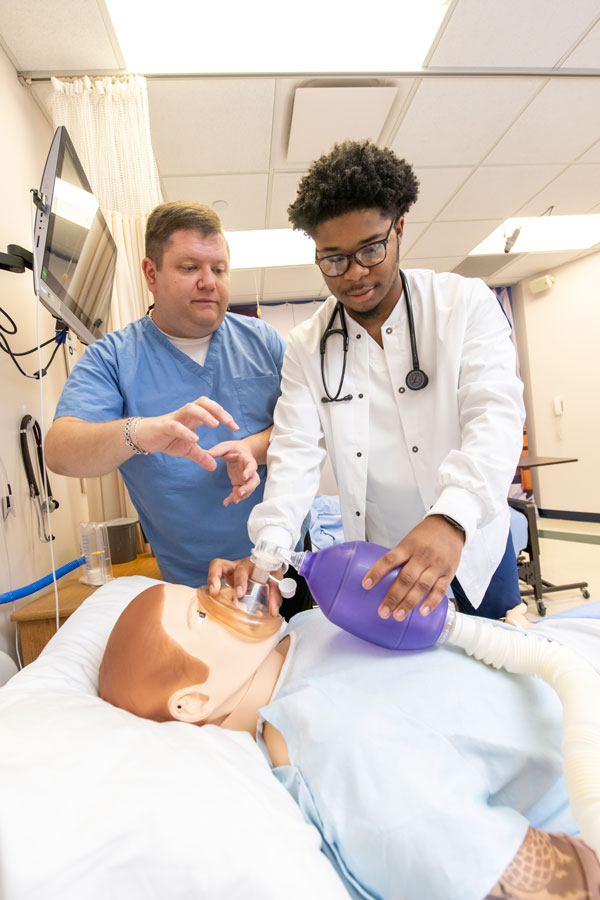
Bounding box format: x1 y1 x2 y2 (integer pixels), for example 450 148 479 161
98 584 283 725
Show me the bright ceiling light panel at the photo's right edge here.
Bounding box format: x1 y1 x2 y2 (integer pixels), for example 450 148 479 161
469 215 600 256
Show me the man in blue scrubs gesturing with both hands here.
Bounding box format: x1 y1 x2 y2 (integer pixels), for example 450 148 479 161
45 202 285 585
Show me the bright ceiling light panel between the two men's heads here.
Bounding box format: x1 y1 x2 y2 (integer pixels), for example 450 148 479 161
225 228 315 269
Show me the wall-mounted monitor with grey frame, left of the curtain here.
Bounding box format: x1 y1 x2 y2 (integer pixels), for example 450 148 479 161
33 125 117 344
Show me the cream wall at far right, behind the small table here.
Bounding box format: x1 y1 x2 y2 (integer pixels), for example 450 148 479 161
513 253 600 514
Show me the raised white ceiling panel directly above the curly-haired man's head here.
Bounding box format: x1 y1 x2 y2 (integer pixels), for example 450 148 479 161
287 86 396 163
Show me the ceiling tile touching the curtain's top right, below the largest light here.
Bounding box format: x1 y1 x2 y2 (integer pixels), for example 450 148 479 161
148 78 274 177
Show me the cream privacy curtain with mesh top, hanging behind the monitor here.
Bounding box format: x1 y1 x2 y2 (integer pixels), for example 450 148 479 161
51 75 163 522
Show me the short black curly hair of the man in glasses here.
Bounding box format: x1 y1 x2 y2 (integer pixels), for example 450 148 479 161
288 141 419 237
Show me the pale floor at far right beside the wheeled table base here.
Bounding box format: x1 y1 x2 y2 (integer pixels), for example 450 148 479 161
526 518 600 620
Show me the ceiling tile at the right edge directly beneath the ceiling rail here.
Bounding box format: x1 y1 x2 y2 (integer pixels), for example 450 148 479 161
485 78 600 164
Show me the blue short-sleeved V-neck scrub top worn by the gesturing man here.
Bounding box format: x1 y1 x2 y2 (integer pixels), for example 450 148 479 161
55 313 285 587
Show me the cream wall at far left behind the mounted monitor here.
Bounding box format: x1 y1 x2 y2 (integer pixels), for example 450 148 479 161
0 49 88 656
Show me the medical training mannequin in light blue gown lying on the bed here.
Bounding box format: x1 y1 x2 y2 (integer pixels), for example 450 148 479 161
99 585 600 900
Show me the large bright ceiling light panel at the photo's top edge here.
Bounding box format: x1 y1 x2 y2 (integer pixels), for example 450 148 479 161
105 0 449 75
